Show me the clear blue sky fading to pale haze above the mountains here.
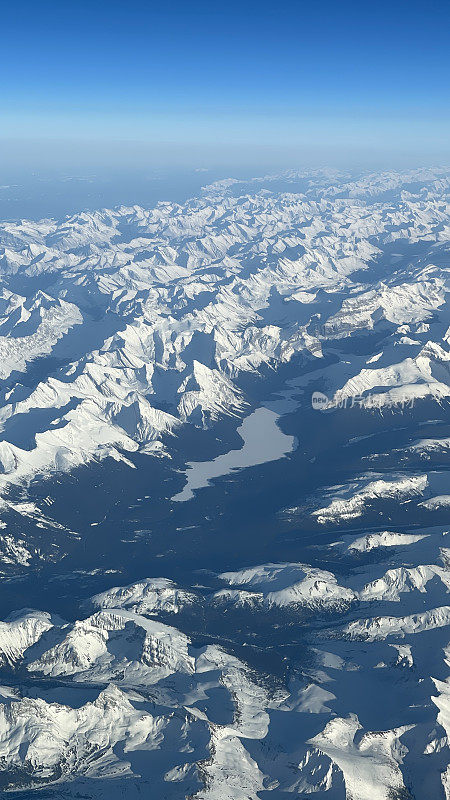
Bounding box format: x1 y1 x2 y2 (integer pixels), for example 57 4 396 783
0 0 450 169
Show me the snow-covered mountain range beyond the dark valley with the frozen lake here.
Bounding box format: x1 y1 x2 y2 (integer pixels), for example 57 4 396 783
0 167 450 494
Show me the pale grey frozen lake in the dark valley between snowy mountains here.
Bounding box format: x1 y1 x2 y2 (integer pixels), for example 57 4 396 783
172 402 295 502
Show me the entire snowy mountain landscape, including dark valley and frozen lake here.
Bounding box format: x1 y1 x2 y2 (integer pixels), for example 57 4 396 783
0 169 450 800
